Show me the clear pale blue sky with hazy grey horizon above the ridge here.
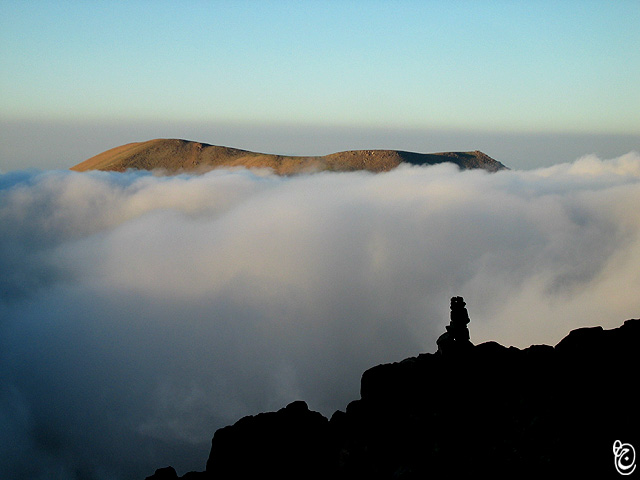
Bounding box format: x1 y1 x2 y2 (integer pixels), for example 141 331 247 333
0 0 640 171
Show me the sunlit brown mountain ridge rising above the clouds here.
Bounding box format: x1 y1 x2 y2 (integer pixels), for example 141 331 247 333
71 139 506 175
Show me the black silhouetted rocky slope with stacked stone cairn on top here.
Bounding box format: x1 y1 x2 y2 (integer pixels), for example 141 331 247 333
149 297 640 480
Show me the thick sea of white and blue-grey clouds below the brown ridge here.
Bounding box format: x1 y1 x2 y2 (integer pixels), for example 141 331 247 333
0 152 640 480
